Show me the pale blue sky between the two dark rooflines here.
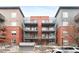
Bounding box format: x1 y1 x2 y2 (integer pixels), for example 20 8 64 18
21 6 59 17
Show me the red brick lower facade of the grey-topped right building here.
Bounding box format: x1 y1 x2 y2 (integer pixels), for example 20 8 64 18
57 26 75 45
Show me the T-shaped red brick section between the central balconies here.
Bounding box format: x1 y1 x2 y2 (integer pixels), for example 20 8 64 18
30 16 49 45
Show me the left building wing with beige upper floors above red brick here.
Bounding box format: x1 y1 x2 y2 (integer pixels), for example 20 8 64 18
0 7 24 44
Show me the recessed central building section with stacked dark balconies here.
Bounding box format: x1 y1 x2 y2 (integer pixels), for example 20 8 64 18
23 16 56 45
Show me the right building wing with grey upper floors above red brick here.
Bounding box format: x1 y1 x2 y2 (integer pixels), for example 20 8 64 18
55 6 79 45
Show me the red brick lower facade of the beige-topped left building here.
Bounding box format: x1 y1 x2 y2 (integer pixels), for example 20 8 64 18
6 26 23 44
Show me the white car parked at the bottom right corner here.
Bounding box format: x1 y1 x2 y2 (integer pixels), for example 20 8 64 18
52 46 79 53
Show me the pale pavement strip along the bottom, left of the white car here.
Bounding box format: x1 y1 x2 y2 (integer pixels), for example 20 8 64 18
0 45 54 53
